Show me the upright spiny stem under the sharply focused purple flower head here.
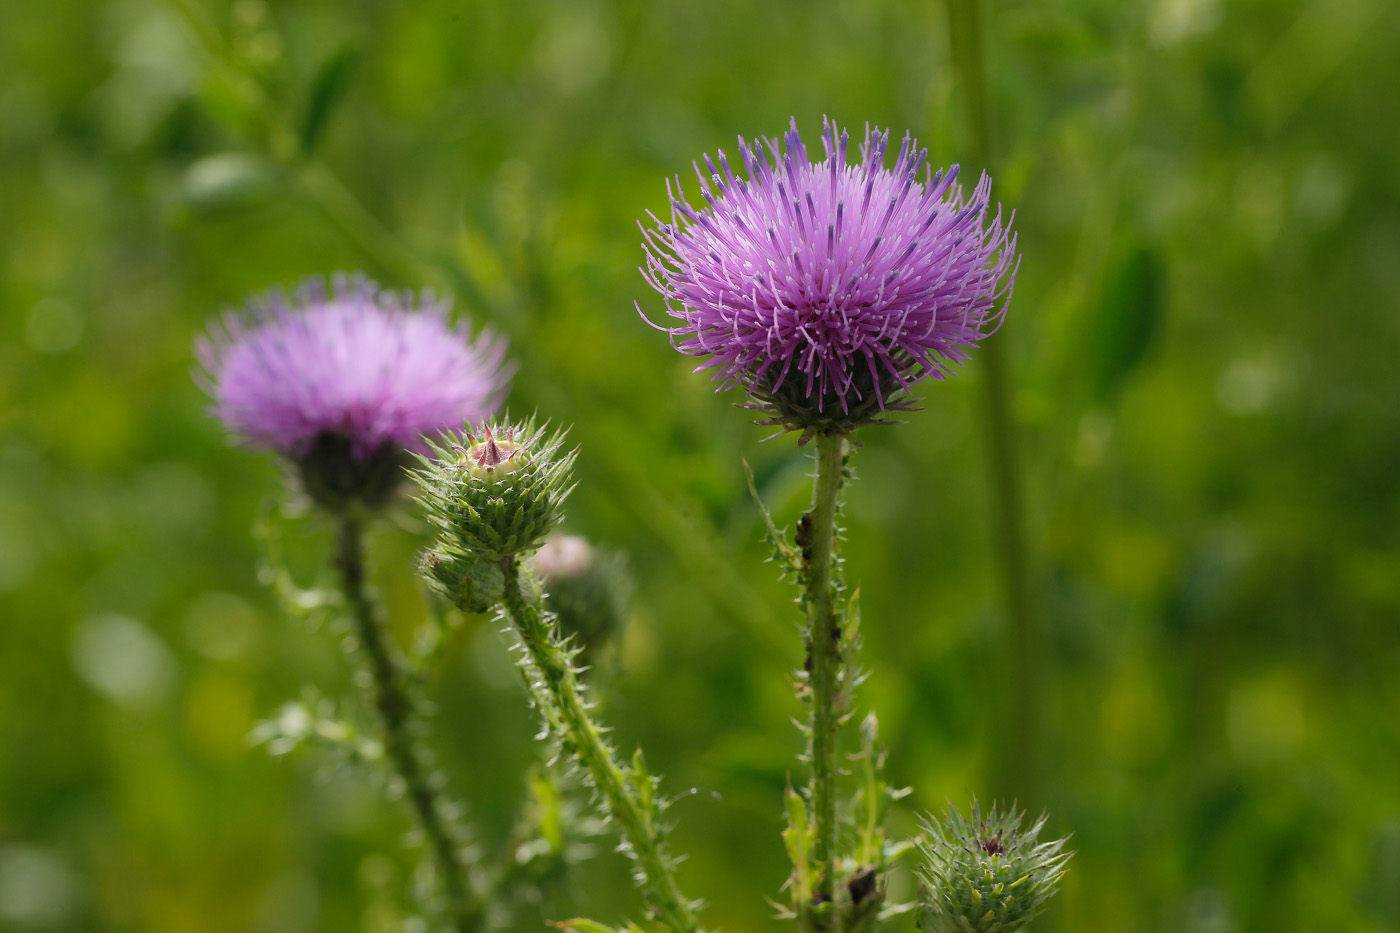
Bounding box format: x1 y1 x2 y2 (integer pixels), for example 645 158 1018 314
798 434 846 923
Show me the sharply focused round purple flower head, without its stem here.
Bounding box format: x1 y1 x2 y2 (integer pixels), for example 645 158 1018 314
638 120 1016 433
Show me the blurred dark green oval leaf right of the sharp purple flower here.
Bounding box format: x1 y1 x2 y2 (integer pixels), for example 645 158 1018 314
1089 247 1165 405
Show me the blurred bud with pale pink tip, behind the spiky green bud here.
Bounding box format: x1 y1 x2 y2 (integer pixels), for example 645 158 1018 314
535 532 631 663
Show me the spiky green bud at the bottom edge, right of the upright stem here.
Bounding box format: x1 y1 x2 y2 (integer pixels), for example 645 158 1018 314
918 801 1072 933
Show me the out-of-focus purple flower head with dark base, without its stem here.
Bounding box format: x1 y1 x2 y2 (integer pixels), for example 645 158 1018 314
197 276 510 504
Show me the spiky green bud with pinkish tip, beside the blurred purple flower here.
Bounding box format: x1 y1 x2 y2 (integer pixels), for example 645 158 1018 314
413 420 575 560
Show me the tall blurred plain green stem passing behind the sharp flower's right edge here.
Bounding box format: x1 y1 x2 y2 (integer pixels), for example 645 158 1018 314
948 0 1036 803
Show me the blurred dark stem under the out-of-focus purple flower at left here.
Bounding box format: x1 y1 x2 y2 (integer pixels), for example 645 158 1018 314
336 514 486 933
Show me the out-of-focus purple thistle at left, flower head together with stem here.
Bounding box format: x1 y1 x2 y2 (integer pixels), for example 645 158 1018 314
197 277 508 933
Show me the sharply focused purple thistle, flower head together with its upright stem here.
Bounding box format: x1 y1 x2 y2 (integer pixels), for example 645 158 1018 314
638 120 1058 930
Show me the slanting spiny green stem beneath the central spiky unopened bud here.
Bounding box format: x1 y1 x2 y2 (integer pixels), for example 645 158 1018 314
501 558 700 933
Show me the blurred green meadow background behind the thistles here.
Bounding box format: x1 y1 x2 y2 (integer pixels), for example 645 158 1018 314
0 0 1400 933
